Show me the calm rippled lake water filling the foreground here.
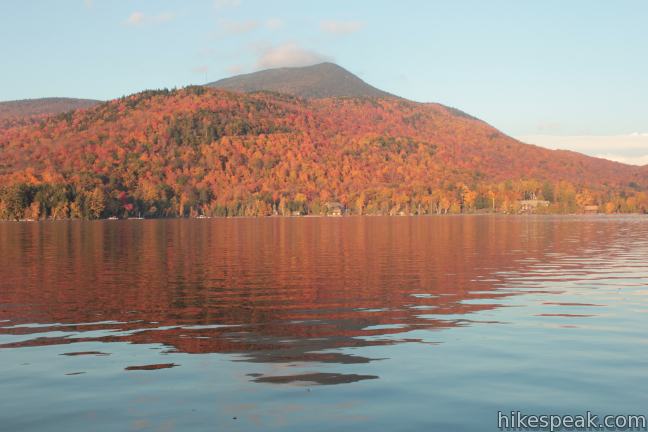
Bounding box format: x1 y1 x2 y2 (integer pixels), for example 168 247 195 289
0 216 648 432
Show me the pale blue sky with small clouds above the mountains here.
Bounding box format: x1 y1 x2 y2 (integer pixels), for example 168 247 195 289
0 0 648 164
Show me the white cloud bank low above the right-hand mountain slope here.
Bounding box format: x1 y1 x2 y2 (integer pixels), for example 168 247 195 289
517 132 648 165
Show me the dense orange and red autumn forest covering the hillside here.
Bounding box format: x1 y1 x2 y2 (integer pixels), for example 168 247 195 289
0 87 648 220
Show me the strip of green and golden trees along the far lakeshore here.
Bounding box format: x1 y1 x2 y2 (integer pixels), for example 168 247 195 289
0 181 648 220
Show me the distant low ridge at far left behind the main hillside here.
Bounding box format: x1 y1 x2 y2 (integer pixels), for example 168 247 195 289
0 98 101 128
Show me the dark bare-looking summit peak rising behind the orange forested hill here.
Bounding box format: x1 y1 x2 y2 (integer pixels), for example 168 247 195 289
207 63 395 99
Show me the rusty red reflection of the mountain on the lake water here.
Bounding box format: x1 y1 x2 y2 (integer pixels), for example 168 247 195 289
0 217 632 384
